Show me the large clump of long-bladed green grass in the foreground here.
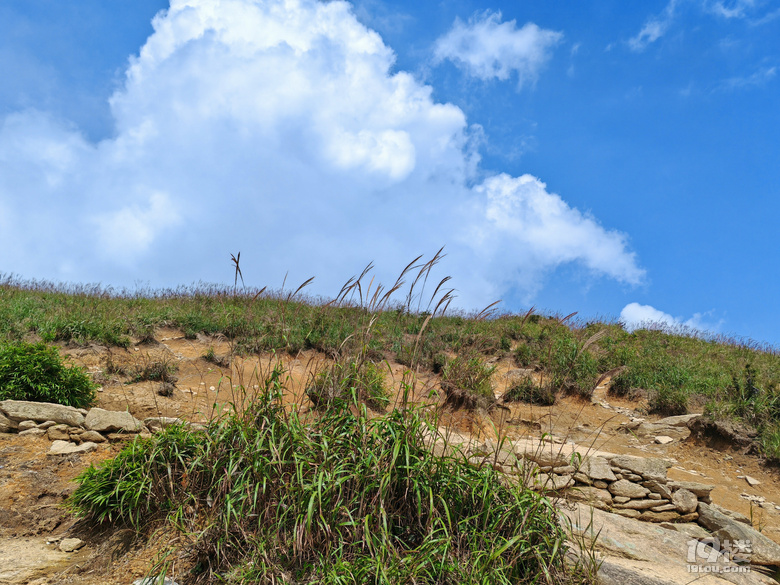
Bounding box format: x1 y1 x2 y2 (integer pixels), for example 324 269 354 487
70 369 575 585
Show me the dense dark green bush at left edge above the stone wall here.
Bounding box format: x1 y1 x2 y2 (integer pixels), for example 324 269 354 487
0 343 96 408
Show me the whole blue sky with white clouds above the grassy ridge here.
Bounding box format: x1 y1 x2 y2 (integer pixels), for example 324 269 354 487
0 0 780 344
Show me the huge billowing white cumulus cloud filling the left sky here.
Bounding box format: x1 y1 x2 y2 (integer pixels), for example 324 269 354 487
0 0 643 306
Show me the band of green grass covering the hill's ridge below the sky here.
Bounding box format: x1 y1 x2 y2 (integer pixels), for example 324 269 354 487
0 256 780 456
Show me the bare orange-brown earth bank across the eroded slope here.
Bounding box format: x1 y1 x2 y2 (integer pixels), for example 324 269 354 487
0 329 780 585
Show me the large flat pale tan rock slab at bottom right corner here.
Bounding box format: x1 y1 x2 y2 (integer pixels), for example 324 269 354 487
559 504 777 585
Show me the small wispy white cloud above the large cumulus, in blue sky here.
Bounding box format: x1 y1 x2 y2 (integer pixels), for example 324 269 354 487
434 11 563 87
